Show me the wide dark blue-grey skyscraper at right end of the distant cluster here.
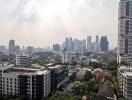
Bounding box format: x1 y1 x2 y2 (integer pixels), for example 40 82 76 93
100 36 109 52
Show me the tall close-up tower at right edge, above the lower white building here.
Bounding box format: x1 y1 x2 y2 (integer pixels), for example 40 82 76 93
118 0 132 65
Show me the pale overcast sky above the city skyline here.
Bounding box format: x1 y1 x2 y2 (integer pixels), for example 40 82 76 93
0 0 119 47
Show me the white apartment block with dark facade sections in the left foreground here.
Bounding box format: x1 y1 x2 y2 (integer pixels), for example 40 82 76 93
0 65 51 100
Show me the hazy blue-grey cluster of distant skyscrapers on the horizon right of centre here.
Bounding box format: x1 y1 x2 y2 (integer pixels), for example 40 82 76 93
53 35 109 53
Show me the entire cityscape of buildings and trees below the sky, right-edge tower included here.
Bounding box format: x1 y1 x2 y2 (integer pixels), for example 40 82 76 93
0 0 132 100
